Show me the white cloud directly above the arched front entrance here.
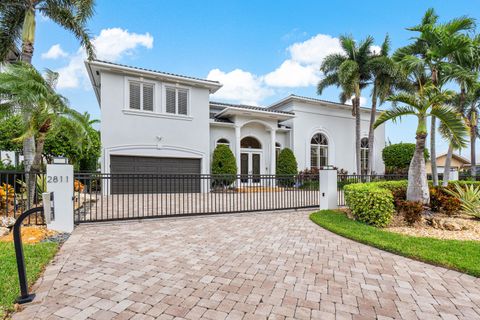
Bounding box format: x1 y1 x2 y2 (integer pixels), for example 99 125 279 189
207 69 273 105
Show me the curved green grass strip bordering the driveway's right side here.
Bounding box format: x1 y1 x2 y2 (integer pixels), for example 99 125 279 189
310 210 480 277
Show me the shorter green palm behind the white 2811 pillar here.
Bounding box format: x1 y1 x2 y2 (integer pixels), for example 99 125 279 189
0 62 86 205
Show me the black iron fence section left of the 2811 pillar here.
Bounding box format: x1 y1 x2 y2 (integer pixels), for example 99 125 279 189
0 171 47 225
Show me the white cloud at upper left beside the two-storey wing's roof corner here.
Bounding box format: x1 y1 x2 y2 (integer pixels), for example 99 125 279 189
57 28 153 89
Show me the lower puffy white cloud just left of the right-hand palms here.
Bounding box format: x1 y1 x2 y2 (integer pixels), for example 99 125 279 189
264 60 320 88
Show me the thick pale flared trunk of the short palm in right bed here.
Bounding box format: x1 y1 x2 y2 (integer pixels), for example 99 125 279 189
407 133 430 203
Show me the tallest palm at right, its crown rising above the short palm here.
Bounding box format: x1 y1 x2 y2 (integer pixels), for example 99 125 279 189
394 9 475 185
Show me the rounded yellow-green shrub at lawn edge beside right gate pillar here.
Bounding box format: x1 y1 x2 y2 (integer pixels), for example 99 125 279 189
344 183 395 227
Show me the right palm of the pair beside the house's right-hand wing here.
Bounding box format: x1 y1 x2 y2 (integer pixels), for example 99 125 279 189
367 35 411 175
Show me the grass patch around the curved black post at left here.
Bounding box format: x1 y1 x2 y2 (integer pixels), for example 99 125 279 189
0 242 58 319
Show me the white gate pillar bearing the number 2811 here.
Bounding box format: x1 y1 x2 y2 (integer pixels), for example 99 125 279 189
47 164 74 233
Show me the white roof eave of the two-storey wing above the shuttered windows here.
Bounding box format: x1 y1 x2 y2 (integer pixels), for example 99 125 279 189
85 60 222 102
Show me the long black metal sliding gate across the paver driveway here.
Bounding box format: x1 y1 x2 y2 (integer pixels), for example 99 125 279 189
74 173 319 223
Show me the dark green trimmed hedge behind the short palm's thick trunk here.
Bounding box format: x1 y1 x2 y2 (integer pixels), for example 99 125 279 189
382 143 429 173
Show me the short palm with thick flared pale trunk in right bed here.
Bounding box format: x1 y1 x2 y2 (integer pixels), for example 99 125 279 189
375 83 466 203
